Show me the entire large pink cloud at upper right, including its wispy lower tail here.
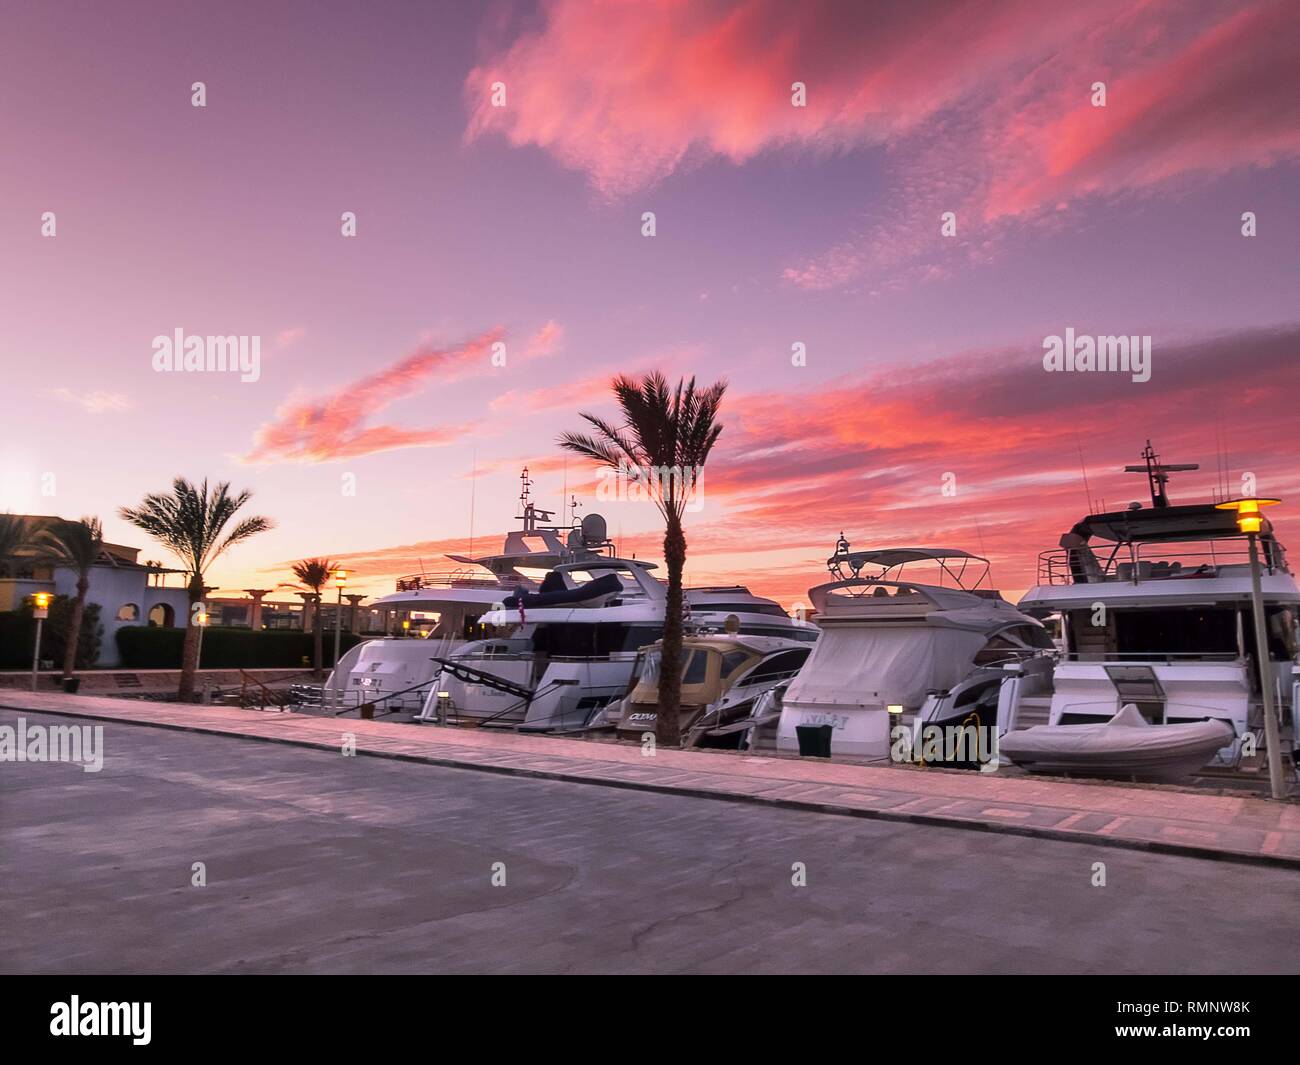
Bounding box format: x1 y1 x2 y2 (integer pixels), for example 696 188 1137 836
464 0 1300 289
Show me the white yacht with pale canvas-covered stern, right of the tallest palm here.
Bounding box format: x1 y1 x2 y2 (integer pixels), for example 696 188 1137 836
769 546 1053 761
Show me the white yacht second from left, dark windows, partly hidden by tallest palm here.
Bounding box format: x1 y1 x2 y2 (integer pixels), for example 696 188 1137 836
420 557 816 731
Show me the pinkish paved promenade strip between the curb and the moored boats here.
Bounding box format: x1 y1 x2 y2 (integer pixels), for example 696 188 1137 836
0 692 1300 869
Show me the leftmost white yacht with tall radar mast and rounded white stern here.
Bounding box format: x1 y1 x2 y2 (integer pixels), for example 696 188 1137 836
322 467 612 713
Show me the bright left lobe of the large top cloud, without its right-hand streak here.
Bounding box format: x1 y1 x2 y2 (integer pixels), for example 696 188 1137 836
465 0 1119 196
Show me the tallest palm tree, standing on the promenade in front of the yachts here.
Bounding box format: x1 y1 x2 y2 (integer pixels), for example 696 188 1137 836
559 372 727 745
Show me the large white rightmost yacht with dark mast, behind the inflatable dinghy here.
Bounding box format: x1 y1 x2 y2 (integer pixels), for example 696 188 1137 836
1000 441 1300 767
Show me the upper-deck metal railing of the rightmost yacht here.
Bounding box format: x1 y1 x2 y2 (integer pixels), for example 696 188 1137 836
1037 540 1282 585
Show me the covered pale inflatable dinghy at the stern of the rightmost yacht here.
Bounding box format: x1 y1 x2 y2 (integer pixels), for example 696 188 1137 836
998 702 1236 780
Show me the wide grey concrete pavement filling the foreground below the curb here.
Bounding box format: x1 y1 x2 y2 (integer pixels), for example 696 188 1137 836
0 711 1300 972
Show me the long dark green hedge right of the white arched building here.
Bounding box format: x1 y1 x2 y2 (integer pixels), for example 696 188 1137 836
117 625 361 670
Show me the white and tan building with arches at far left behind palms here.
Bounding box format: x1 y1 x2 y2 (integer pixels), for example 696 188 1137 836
0 515 189 667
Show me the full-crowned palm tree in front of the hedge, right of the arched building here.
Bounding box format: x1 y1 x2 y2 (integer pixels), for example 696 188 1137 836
118 477 276 701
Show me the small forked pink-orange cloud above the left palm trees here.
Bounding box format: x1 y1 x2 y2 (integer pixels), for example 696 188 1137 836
243 328 503 463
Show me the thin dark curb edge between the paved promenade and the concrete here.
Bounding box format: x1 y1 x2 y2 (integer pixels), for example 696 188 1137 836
10 702 1300 870
